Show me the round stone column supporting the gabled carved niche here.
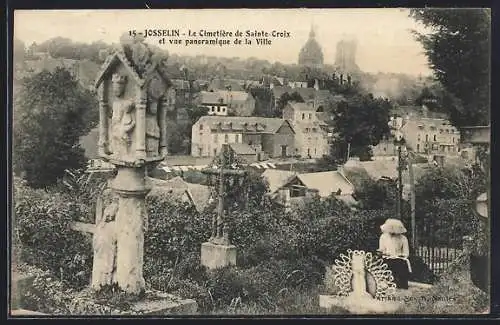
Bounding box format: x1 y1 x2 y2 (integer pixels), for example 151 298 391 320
111 166 151 294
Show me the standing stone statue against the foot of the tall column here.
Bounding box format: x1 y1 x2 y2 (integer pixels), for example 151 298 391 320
92 188 118 290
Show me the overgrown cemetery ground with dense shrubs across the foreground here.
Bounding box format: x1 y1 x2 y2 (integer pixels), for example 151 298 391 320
13 173 489 315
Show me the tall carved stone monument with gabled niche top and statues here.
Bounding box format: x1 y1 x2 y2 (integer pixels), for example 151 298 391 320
72 39 196 314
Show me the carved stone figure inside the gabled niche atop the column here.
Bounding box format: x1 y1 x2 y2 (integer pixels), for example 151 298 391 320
110 74 135 157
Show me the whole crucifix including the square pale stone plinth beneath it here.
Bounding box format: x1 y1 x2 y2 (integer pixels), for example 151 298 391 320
201 144 245 269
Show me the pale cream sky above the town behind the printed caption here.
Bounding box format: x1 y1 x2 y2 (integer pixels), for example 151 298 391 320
14 8 431 76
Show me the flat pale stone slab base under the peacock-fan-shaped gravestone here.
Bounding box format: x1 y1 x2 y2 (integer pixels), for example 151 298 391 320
319 295 401 314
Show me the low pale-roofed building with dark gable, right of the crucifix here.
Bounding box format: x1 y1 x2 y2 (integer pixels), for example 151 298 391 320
262 169 356 205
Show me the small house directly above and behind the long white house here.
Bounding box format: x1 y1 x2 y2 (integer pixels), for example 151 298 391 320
198 90 255 116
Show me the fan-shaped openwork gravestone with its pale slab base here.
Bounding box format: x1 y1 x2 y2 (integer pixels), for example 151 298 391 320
319 250 400 314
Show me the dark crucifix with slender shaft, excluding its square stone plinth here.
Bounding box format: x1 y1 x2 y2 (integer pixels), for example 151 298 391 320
203 144 246 245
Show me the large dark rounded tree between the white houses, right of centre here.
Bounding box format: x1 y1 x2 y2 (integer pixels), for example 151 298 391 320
330 94 391 162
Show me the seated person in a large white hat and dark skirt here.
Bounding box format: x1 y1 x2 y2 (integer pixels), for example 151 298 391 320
378 218 411 289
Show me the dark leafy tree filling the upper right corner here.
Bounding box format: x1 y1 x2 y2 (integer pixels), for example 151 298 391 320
410 8 491 127
